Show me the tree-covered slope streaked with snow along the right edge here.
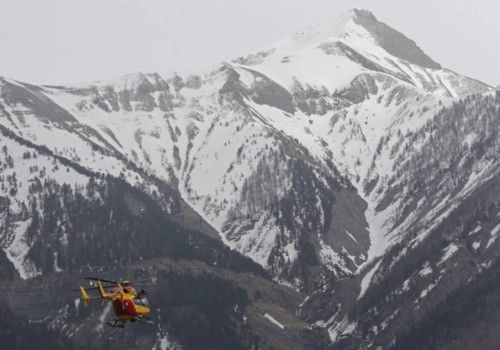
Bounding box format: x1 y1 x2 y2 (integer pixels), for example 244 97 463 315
303 92 500 349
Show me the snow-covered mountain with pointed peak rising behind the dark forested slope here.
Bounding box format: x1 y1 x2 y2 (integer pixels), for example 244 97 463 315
0 9 500 348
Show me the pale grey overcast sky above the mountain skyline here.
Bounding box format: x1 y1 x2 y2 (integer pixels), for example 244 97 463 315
0 0 500 85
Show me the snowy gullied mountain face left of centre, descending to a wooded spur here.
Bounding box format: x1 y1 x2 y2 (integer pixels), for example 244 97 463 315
3 67 368 286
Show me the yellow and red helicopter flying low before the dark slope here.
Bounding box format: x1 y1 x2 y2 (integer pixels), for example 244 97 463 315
76 277 153 328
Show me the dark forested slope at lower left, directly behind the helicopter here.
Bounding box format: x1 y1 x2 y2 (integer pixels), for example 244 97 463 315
0 130 327 349
